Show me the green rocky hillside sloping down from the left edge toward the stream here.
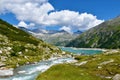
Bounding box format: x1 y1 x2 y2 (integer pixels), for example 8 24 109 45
0 19 62 69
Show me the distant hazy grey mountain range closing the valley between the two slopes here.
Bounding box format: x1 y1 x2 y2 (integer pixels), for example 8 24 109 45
20 28 82 46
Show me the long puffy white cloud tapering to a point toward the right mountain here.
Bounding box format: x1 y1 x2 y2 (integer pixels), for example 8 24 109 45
43 10 104 29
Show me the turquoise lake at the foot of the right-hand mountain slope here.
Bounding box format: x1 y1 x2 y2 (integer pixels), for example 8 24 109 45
60 47 102 55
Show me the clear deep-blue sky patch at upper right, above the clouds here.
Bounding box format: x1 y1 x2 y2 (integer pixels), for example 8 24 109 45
49 0 120 20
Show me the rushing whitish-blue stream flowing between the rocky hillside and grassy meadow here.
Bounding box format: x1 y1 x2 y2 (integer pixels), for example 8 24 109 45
0 57 75 80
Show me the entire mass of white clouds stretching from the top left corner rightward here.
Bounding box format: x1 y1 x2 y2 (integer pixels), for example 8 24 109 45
0 0 104 31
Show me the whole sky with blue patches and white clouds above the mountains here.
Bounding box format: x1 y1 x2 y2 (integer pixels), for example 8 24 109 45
0 0 120 32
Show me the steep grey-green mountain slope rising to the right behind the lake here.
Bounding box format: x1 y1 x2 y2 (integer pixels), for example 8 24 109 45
66 16 120 49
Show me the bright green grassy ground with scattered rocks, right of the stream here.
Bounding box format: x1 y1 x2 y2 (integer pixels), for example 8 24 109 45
36 50 120 80
